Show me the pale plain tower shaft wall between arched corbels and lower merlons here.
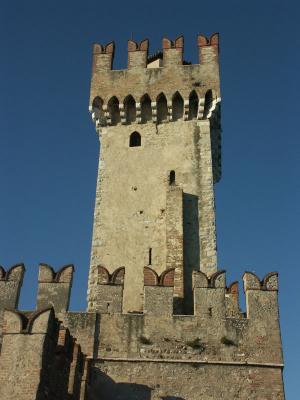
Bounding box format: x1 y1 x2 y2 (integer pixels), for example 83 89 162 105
88 121 216 311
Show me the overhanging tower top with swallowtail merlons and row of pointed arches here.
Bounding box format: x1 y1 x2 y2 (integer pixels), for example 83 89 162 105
89 33 220 130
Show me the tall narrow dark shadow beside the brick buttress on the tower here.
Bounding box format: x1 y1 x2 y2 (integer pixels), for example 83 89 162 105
183 193 200 314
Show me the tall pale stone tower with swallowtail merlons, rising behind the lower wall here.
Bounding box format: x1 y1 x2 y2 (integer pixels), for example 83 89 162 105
88 34 221 312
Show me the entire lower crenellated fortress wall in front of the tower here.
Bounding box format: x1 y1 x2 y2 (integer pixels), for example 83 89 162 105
0 265 284 400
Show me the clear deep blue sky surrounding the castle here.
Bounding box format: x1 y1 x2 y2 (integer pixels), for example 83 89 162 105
0 0 300 400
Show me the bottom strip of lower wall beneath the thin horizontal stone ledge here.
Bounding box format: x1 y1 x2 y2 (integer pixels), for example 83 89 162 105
90 361 284 400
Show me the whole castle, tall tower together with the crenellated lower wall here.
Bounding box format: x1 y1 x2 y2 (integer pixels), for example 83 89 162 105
0 34 284 400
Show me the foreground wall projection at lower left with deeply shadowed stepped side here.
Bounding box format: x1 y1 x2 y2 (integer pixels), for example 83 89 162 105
0 308 88 400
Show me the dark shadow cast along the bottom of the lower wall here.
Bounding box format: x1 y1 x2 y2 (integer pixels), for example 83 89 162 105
89 368 185 400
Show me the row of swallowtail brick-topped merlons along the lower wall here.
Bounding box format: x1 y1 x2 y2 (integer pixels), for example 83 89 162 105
0 264 278 322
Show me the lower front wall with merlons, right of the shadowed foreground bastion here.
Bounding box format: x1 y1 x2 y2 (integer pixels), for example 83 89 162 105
85 272 284 400
